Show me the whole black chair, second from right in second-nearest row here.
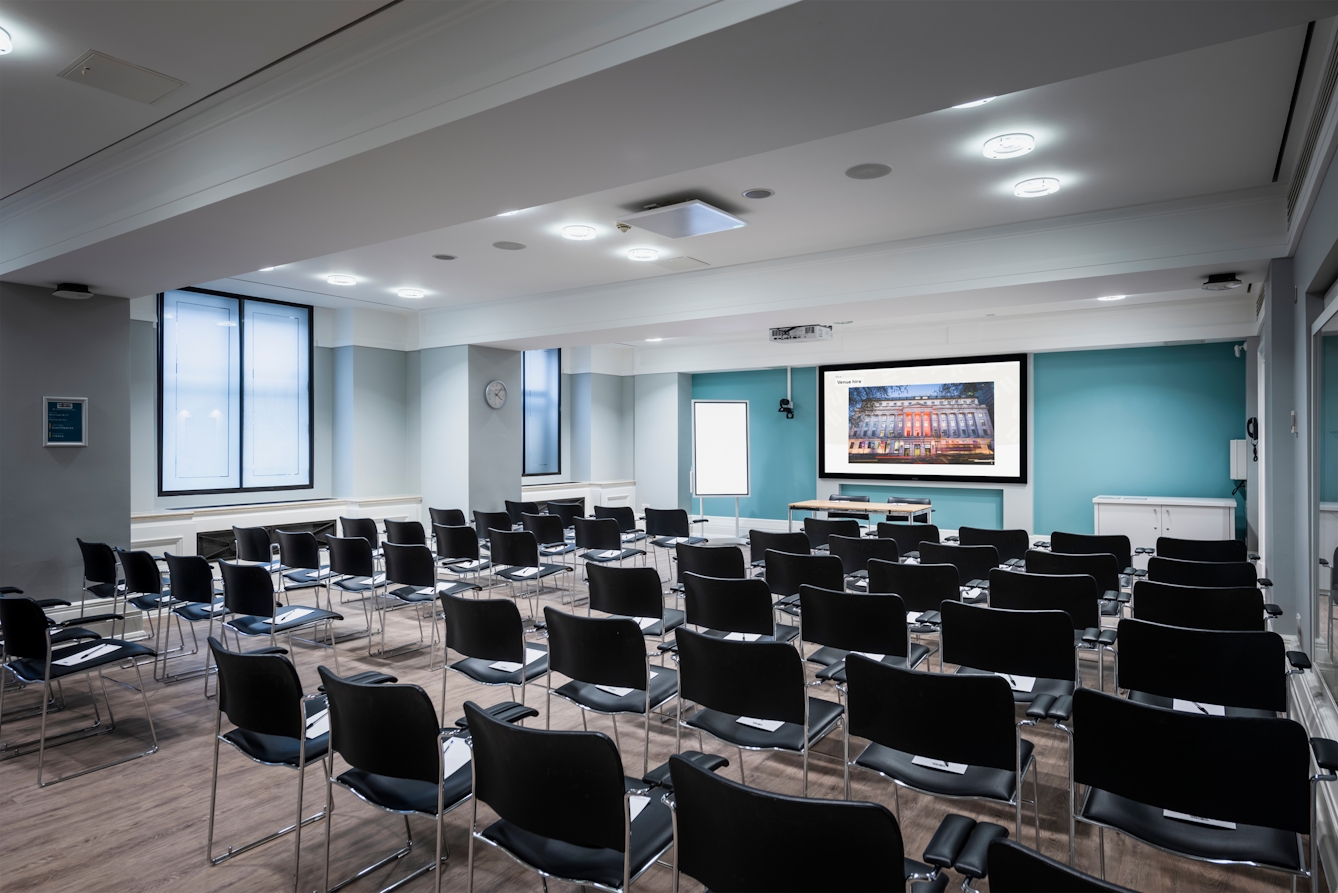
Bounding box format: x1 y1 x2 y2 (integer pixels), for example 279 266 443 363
844 653 1041 845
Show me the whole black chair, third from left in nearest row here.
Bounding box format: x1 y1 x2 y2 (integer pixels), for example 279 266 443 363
464 702 673 892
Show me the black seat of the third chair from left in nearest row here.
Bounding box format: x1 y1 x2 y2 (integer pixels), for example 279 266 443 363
479 778 673 888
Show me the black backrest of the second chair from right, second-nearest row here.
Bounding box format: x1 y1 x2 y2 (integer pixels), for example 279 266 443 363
846 655 1017 771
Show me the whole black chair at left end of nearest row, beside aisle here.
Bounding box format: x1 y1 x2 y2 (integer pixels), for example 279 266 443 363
206 636 330 893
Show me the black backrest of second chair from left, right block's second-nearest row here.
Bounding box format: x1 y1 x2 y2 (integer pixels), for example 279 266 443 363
543 607 654 691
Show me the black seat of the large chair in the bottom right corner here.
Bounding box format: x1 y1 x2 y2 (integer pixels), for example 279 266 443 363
1080 787 1301 872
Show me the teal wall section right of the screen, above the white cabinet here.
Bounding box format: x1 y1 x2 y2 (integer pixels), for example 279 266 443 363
1033 343 1246 536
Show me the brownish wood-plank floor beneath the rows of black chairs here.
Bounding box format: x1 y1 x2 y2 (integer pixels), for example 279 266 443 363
0 570 1305 893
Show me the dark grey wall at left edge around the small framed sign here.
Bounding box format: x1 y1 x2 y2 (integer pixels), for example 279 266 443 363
0 282 131 598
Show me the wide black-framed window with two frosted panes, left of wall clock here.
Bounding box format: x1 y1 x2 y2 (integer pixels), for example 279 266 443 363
158 289 312 495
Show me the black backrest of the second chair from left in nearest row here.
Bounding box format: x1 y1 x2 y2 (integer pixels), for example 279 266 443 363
317 667 442 786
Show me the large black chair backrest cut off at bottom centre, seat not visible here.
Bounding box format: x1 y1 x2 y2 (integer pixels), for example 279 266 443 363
669 754 906 890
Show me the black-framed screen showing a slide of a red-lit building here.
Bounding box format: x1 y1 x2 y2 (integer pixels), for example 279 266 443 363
820 359 1025 481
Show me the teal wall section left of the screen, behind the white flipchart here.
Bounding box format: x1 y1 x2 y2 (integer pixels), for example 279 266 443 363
692 366 818 518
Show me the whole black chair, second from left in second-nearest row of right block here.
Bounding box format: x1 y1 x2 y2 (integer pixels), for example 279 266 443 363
543 607 678 775
